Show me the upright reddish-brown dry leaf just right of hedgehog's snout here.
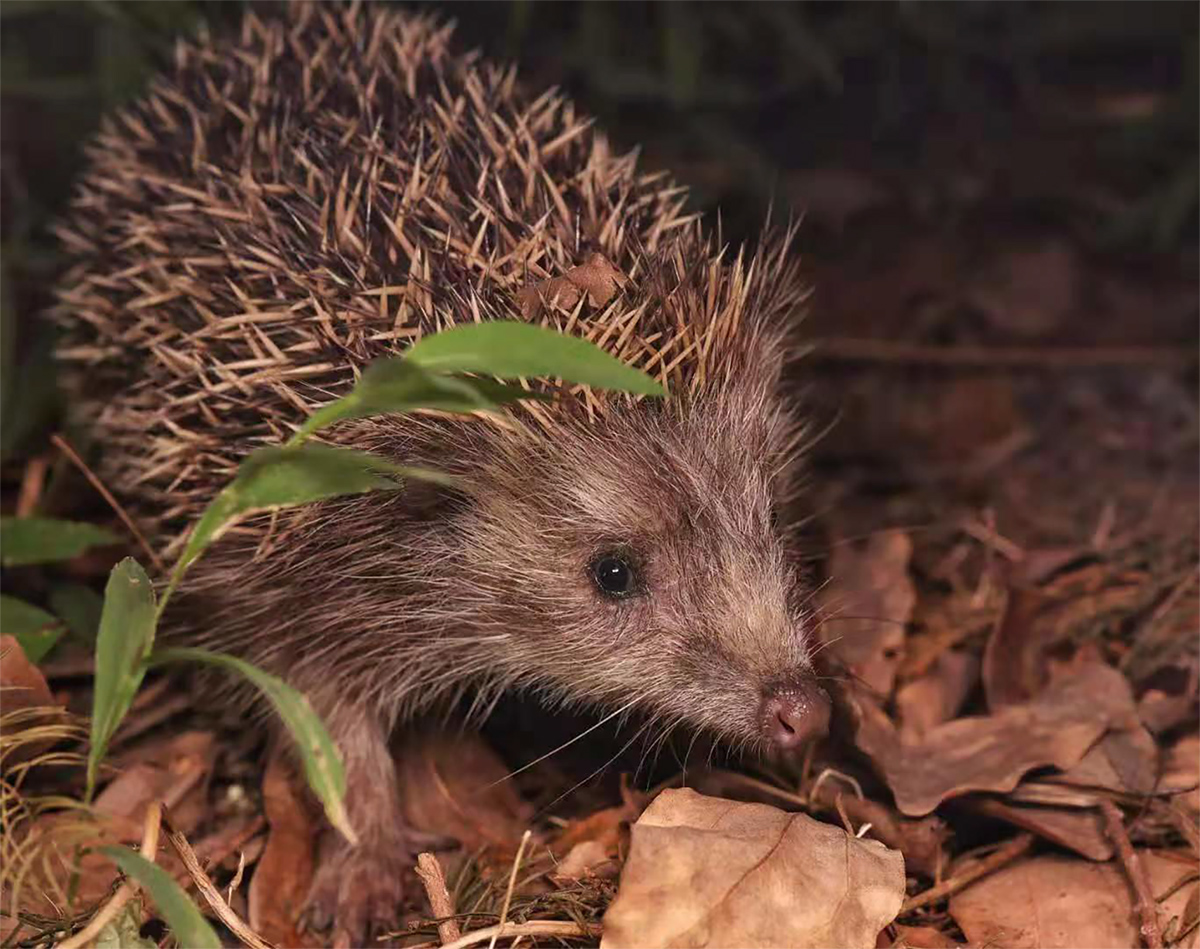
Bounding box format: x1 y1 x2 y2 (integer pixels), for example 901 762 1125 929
820 530 917 697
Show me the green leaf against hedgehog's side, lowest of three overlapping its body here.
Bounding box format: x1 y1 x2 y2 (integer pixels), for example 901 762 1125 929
170 444 452 589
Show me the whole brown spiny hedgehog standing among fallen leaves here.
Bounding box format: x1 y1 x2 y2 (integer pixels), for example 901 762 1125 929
54 4 829 944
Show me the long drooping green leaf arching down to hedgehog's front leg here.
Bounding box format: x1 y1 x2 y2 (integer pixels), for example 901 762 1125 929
150 647 356 843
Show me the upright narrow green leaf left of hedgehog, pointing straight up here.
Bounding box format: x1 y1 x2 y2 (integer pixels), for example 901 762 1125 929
88 557 157 799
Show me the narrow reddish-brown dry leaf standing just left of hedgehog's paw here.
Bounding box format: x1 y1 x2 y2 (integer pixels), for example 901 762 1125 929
248 755 319 947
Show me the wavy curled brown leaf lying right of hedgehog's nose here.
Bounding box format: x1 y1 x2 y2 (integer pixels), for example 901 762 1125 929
845 662 1135 816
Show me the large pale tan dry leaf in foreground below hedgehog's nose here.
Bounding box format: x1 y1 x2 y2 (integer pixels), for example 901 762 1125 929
600 788 905 949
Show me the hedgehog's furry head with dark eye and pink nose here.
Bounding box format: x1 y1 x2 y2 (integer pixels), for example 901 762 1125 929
455 374 829 749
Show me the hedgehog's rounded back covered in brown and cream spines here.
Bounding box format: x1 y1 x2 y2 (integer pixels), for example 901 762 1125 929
56 5 806 551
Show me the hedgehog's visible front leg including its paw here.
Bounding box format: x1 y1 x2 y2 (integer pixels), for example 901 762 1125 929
304 697 420 945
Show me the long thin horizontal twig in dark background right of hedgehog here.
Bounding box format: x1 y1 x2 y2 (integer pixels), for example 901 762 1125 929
808 337 1196 368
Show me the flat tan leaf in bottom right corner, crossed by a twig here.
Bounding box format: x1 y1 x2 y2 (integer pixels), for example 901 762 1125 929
950 851 1200 949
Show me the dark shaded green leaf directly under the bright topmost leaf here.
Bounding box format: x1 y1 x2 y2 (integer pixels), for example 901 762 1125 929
292 359 538 443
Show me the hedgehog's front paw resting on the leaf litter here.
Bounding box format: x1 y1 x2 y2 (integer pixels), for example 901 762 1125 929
302 841 413 947
